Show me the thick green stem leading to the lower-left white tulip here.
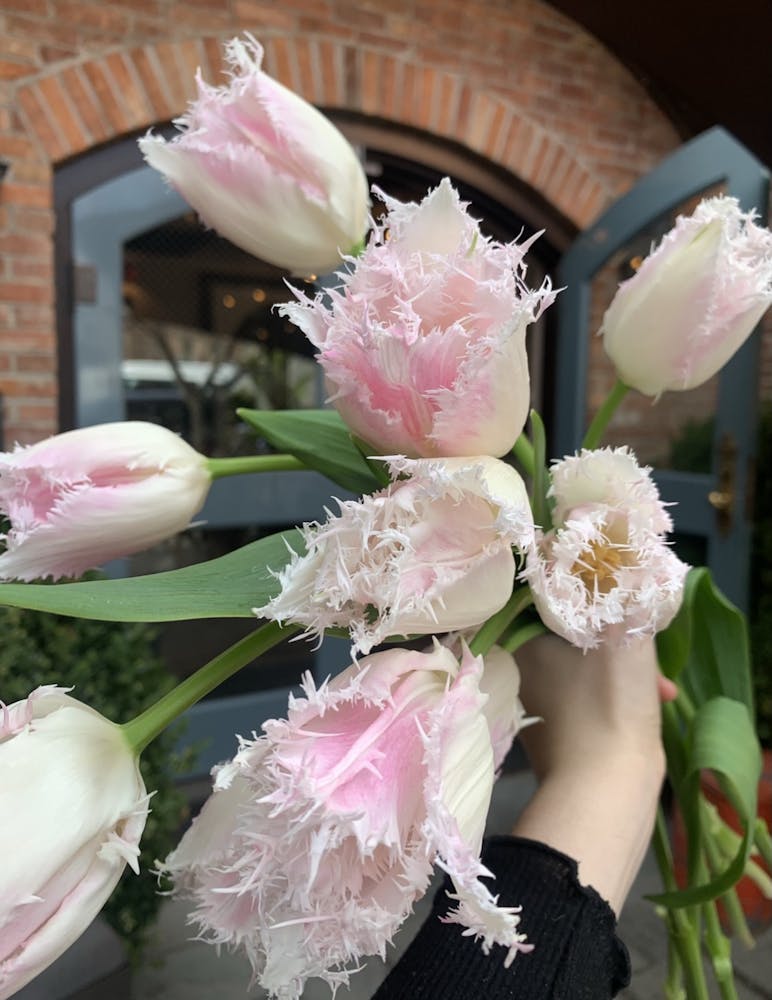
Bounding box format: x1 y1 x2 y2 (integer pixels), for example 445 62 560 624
121 622 300 756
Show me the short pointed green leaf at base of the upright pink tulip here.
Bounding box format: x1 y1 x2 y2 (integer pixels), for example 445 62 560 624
236 409 381 494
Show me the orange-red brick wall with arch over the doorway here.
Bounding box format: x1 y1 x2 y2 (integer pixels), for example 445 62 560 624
0 0 678 443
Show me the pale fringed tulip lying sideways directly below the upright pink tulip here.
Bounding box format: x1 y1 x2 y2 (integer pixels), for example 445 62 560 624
255 456 533 653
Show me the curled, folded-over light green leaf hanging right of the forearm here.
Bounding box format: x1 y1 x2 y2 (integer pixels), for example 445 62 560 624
649 697 762 909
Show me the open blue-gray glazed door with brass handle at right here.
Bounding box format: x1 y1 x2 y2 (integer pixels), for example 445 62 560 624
553 128 769 609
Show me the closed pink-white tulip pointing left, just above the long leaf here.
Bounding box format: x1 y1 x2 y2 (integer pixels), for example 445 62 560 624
0 421 211 580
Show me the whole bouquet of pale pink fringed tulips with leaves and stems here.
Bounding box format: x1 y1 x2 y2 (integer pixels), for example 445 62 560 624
0 38 772 998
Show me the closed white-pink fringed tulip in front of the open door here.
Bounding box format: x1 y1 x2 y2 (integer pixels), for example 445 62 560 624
602 197 772 396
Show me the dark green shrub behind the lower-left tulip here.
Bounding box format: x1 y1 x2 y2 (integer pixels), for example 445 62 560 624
0 588 191 958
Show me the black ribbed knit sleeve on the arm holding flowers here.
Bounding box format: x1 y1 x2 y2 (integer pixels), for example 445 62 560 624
373 837 630 1000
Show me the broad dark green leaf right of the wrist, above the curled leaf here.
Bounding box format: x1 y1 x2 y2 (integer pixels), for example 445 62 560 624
657 566 753 717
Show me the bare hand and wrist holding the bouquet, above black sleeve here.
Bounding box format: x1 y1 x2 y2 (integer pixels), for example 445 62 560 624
513 635 673 913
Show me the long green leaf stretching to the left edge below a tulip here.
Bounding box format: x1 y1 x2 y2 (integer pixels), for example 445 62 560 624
0 529 305 622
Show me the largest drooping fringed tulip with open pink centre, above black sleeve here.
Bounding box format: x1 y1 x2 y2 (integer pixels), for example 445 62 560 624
164 645 530 1000
